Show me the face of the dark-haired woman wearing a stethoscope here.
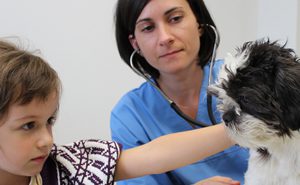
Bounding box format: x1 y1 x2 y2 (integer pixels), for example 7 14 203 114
129 0 202 75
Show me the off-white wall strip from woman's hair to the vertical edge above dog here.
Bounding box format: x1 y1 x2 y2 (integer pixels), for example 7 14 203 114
204 0 258 58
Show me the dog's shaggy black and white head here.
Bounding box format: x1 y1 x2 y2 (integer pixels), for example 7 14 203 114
208 40 300 148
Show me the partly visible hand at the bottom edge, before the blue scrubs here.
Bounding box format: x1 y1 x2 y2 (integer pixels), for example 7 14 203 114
194 176 240 185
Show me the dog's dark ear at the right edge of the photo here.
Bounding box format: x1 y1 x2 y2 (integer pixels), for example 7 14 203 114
274 60 300 130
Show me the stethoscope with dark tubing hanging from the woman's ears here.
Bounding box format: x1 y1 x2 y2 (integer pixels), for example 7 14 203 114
130 24 219 127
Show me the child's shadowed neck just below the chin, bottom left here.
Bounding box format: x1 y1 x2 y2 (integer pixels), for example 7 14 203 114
0 169 30 185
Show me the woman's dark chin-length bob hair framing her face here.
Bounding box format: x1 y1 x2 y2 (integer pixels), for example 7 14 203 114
115 0 219 79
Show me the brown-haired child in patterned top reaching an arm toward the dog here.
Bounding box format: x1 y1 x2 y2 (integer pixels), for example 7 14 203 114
0 40 239 185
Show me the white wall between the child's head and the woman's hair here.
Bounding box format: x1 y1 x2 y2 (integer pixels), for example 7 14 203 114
0 0 142 143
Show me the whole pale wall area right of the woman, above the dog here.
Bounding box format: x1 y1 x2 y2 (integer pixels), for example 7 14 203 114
204 0 300 58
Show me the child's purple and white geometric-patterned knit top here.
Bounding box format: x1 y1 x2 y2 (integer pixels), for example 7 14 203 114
41 140 121 185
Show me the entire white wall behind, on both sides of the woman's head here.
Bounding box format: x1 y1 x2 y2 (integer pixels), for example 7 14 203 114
0 0 300 143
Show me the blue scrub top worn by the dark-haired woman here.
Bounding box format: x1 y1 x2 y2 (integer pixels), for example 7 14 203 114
110 60 249 185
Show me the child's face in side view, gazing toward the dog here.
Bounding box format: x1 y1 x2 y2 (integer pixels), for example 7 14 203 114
0 93 58 177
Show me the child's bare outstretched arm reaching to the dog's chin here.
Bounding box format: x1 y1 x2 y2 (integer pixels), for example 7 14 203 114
115 124 234 181
